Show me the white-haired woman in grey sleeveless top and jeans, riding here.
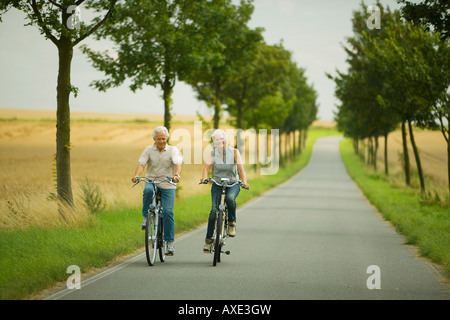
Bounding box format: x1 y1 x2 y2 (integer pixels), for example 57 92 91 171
200 129 249 253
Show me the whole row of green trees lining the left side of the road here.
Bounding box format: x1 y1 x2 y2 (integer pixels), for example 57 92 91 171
0 0 318 214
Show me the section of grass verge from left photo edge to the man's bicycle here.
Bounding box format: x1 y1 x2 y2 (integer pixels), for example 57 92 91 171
0 209 142 299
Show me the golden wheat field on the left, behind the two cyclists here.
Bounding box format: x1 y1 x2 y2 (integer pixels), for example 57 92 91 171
0 109 214 228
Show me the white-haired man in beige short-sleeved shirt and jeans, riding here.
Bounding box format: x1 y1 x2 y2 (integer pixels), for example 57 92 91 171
131 127 183 256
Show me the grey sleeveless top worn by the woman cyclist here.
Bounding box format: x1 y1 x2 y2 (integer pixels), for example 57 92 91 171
211 146 239 183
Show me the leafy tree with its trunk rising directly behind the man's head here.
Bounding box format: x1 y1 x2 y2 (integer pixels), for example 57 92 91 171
82 0 223 130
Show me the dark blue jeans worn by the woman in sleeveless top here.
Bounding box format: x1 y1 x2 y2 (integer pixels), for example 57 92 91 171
206 184 241 239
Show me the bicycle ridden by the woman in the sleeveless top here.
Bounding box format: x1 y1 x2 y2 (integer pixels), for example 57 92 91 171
199 178 249 266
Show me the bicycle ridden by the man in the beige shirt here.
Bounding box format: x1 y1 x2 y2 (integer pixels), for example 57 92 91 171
133 177 176 267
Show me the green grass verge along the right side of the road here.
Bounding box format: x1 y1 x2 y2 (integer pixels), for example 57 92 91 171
340 139 450 279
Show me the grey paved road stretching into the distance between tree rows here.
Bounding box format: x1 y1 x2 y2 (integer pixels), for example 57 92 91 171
48 137 450 300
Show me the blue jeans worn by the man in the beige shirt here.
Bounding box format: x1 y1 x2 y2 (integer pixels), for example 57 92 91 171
142 183 176 242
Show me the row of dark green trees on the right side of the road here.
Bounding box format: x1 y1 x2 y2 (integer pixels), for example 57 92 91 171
328 0 450 194
